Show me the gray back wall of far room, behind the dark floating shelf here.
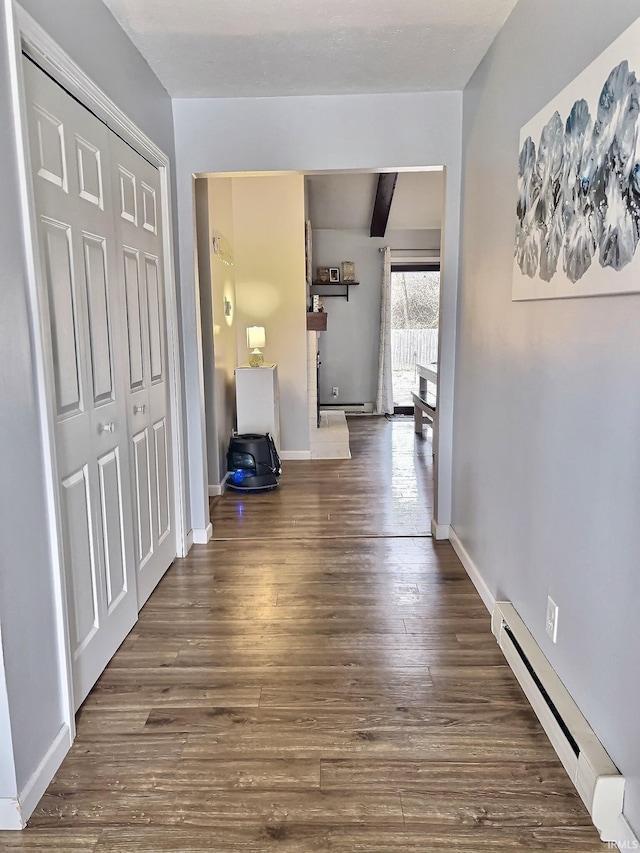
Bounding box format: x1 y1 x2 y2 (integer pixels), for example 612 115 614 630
311 228 440 404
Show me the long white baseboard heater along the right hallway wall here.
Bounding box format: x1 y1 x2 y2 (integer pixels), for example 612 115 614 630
491 601 624 841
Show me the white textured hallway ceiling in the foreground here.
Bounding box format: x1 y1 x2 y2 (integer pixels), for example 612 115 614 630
104 0 517 98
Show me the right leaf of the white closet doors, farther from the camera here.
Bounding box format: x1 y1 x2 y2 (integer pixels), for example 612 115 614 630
110 134 176 607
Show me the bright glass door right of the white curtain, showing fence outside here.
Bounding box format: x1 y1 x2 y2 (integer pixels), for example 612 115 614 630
391 261 440 415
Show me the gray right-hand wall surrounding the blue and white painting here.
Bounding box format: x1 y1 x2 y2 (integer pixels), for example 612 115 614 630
453 0 640 832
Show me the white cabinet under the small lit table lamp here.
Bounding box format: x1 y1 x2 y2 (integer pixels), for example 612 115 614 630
236 364 280 451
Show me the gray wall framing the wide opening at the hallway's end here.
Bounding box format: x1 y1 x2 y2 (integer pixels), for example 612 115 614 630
173 92 462 527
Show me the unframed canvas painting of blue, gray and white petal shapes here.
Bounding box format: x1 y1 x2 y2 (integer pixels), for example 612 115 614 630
513 19 640 300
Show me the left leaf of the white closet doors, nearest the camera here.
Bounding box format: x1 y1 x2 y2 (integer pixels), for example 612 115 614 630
24 60 138 707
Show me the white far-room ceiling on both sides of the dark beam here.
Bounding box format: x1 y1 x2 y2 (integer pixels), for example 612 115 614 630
305 170 444 231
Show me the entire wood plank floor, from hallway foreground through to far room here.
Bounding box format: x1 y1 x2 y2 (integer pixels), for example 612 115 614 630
0 418 606 853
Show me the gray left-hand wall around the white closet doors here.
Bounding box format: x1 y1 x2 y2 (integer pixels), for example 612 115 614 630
0 0 173 797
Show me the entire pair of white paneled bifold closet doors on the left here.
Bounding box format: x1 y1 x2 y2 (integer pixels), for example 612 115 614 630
24 59 175 707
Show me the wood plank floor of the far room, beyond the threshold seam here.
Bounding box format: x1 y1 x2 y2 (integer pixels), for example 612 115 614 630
211 417 433 550
